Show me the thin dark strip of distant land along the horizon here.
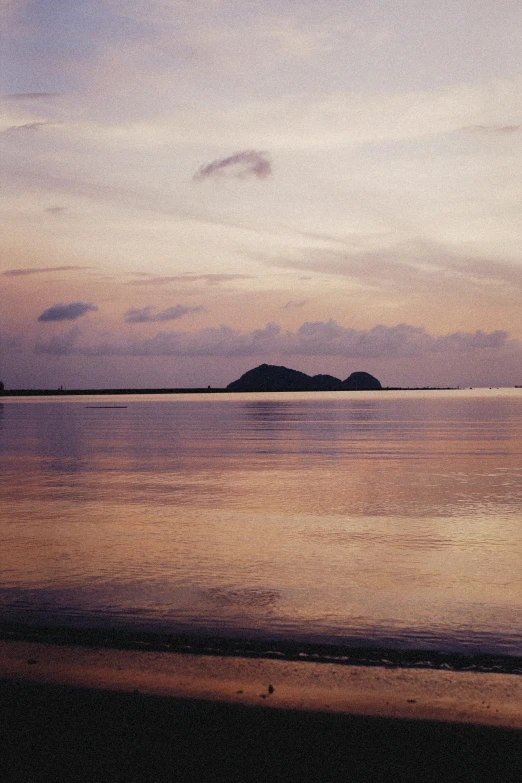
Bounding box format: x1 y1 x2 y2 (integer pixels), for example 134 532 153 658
0 386 458 397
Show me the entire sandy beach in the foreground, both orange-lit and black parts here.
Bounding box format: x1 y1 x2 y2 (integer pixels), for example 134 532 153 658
0 642 522 783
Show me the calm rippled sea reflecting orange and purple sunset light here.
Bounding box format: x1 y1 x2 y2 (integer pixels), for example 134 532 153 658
0 389 522 656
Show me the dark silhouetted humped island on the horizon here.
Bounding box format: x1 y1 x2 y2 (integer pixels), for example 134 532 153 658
226 364 382 392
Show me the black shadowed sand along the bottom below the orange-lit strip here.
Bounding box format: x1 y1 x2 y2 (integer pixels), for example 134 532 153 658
0 681 522 783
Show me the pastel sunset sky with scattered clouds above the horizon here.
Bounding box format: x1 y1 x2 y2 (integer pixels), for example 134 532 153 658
0 0 522 388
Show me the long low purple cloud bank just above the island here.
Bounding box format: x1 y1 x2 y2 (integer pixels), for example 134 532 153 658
35 319 522 361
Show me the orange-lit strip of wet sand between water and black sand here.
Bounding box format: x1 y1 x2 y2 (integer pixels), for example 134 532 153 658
0 641 522 731
